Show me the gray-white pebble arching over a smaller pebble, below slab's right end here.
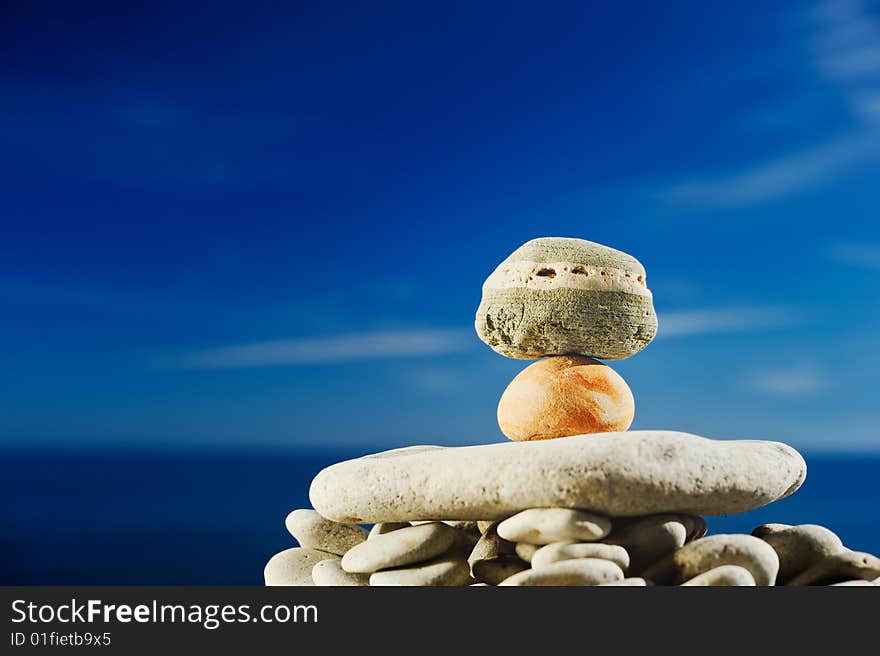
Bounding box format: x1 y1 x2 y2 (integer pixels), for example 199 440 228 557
643 534 779 586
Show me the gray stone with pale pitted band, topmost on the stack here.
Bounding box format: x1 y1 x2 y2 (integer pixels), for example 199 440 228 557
475 237 657 360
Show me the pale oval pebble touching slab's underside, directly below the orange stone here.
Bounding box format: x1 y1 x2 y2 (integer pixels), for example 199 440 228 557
497 508 611 544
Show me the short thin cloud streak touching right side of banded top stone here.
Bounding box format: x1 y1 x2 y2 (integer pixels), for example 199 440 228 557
657 306 802 339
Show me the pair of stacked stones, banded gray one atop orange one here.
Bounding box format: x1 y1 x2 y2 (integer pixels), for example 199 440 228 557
475 237 657 441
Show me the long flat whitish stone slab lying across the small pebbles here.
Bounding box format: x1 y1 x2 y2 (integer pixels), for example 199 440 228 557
309 431 806 523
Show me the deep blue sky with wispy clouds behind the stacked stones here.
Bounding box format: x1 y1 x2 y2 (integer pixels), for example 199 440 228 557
0 0 880 450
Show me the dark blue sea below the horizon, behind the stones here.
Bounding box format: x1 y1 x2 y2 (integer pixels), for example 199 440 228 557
0 449 880 585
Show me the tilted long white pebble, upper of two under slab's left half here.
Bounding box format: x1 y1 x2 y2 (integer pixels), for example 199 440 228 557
342 522 456 585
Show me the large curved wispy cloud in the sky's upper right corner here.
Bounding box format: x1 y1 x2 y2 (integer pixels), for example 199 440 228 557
661 0 880 208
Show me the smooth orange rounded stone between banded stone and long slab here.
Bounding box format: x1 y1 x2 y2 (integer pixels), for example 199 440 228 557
498 355 636 442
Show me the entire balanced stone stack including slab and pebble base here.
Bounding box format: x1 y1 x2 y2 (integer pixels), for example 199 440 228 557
264 238 880 586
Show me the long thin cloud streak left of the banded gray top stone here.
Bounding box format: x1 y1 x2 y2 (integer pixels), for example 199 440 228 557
155 329 476 369
